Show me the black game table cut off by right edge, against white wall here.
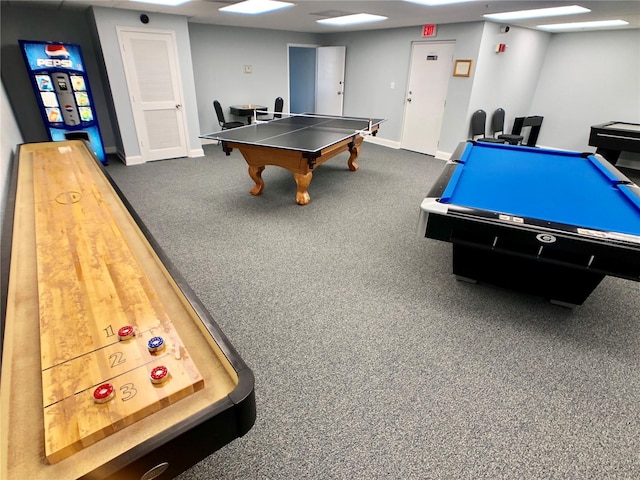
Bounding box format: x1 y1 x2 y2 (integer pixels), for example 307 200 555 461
589 122 640 165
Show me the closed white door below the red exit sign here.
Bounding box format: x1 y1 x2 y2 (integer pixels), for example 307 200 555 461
402 43 455 155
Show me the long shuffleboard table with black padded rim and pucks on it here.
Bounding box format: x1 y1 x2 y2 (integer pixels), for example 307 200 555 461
0 140 256 480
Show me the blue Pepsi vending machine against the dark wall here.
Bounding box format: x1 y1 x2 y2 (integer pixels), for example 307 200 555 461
19 40 107 164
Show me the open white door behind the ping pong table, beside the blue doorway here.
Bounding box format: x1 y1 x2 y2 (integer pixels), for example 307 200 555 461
316 47 347 115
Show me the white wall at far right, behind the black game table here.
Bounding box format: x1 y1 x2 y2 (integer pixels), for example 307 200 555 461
531 30 640 151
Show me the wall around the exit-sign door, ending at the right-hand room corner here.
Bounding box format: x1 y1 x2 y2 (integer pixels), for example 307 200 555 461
324 22 550 157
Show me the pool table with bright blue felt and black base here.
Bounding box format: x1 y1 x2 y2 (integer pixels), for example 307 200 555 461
418 142 640 307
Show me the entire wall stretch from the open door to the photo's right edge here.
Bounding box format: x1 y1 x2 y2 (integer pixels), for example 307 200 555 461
322 22 640 156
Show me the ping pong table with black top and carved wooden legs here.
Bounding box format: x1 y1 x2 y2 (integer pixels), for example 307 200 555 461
201 114 384 205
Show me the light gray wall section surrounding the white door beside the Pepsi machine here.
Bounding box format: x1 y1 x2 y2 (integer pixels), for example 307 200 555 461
93 7 204 164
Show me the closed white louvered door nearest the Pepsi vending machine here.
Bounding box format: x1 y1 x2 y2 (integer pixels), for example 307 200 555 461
118 27 187 162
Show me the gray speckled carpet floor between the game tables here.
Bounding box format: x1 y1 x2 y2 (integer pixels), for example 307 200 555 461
107 143 640 480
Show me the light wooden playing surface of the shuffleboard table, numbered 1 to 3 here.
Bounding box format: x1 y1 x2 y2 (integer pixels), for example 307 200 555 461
32 144 203 463
